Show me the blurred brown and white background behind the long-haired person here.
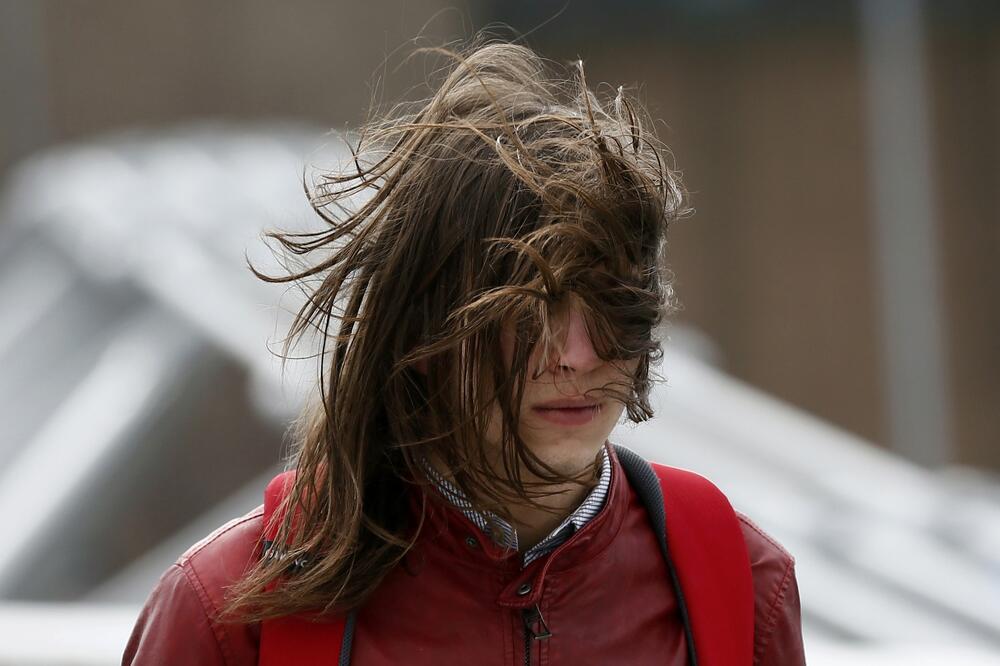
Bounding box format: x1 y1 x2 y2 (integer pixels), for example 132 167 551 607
0 0 1000 665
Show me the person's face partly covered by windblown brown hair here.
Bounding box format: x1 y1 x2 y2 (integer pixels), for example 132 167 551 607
487 294 639 478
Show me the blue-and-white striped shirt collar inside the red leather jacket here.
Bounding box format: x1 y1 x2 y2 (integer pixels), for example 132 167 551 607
425 440 611 567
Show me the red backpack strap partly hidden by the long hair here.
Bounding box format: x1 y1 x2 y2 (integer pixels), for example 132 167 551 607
257 470 354 666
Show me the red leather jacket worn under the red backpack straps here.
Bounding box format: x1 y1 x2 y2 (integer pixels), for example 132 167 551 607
122 448 805 666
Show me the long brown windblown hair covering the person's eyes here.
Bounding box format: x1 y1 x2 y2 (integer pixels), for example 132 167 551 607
220 36 686 620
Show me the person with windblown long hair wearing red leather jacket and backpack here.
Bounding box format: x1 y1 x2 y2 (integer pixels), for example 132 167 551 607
123 40 805 666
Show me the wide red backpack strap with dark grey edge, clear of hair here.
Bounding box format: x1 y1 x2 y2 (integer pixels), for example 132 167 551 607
615 447 754 666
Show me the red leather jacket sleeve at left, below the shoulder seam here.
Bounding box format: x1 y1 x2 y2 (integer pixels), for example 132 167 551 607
122 564 227 666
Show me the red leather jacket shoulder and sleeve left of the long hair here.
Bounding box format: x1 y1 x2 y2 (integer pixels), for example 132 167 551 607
122 507 263 666
